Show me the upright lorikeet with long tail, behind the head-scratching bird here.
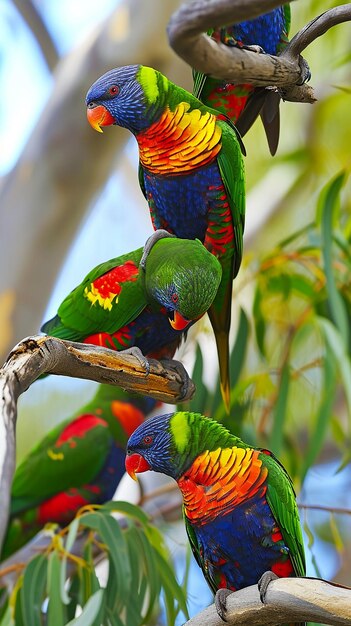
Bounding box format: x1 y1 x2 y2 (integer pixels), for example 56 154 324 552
86 65 245 406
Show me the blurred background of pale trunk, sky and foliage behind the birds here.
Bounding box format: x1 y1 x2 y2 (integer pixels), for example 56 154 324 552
0 0 351 612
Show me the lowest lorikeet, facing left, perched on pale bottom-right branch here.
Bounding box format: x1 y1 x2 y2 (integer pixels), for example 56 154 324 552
126 412 305 616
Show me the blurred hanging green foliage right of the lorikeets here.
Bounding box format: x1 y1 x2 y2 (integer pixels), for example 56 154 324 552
189 173 351 481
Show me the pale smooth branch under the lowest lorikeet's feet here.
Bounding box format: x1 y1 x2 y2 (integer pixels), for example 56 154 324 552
186 578 351 626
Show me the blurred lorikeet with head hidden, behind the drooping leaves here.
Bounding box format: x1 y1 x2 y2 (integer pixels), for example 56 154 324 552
1 385 156 560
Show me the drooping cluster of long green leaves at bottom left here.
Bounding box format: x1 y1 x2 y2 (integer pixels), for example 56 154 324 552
0 502 187 626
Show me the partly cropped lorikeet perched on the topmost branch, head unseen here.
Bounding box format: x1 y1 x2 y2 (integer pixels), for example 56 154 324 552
193 4 291 155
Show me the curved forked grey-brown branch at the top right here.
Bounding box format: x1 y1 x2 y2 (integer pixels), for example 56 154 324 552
168 0 351 102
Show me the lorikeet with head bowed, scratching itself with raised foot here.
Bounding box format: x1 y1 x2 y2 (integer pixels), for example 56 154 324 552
41 231 222 358
